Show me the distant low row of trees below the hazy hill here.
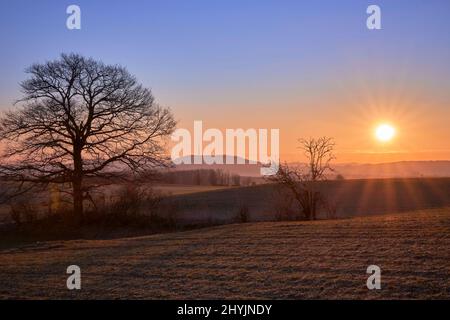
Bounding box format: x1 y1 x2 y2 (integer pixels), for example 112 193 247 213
158 169 253 186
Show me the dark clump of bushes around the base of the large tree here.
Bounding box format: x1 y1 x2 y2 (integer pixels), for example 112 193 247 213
6 184 178 239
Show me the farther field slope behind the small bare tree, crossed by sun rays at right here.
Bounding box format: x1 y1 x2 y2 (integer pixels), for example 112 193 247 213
170 178 450 221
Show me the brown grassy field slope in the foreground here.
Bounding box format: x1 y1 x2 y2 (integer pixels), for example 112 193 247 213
0 208 450 299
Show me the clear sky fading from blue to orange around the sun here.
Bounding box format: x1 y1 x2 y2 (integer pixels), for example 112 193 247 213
0 0 450 162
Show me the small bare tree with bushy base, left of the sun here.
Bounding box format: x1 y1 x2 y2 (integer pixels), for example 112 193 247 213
271 137 335 220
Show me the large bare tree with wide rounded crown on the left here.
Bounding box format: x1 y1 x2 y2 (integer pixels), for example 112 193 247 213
0 54 176 216
